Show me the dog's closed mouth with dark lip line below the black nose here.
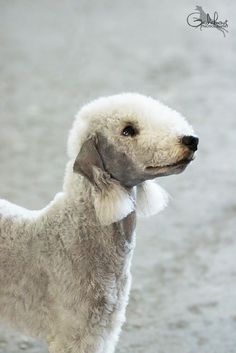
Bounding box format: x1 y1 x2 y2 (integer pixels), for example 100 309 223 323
145 156 194 175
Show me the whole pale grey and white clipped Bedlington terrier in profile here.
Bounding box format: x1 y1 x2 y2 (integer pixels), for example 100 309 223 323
0 93 198 353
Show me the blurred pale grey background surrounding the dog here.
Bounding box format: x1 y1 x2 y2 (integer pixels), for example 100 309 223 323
0 0 236 353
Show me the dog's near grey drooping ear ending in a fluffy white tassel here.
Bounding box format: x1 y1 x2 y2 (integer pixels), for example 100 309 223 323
73 136 134 225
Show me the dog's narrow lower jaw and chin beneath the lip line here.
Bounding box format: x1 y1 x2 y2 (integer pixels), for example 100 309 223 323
145 158 193 179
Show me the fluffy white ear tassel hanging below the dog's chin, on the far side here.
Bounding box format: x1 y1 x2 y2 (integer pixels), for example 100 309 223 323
136 180 169 217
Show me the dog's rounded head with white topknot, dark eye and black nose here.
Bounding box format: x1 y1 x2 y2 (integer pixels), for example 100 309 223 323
68 93 198 224
